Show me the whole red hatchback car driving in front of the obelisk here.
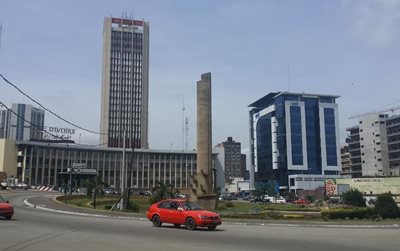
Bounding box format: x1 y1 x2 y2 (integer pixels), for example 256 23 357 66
147 199 222 230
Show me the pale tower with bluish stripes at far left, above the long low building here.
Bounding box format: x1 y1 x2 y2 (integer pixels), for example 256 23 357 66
6 104 44 141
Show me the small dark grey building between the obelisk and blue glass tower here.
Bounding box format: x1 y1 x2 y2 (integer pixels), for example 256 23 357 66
216 137 246 182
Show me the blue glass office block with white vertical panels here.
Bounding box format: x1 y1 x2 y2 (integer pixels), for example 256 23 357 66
249 92 341 191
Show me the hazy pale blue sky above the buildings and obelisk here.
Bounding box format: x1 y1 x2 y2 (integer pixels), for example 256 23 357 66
0 0 400 150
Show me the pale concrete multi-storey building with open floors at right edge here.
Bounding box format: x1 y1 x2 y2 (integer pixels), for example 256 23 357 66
347 114 400 178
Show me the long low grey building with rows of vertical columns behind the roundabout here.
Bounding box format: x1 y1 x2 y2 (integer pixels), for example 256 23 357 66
0 139 223 191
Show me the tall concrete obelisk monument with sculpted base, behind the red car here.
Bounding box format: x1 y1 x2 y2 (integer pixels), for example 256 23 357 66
191 73 217 209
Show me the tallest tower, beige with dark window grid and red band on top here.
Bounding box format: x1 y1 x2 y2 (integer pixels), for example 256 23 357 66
100 17 149 148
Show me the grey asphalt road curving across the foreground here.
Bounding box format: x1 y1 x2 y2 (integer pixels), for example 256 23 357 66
0 191 400 251
